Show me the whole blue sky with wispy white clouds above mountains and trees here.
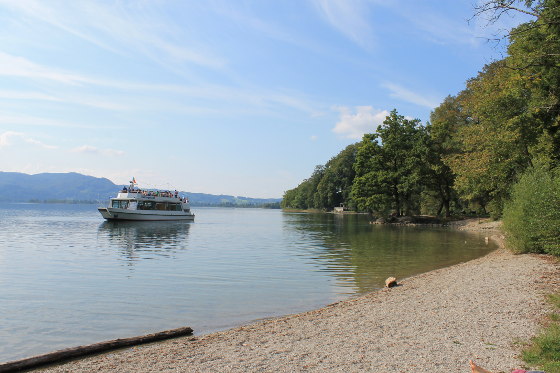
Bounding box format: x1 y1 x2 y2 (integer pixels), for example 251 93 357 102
0 0 523 198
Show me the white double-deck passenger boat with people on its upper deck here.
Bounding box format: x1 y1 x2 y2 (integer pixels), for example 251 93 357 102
98 179 194 220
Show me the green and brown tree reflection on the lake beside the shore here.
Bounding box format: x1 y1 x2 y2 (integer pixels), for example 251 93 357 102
284 213 496 294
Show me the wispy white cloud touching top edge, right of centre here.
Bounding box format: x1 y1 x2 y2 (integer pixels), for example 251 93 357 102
313 0 375 50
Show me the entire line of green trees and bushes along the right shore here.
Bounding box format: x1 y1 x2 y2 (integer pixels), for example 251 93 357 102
282 0 560 254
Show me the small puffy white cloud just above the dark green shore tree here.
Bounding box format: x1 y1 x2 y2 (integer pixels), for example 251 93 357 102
333 106 389 140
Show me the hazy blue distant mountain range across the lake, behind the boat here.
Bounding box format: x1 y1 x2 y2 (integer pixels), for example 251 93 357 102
0 171 281 207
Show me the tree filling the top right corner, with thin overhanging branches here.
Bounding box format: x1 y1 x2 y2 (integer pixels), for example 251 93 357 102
476 0 560 166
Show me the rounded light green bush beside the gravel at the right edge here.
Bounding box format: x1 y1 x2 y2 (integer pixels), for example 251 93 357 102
503 167 560 256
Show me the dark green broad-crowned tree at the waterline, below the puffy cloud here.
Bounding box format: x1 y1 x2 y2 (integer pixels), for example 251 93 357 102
352 110 427 216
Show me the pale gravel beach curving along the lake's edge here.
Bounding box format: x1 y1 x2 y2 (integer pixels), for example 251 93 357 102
40 224 559 372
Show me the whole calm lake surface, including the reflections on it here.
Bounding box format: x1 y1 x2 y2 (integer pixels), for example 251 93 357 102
0 204 495 361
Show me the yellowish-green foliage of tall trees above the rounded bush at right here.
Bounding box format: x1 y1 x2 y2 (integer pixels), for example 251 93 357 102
434 0 560 217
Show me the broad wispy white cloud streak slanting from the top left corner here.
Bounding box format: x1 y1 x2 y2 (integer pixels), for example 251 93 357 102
3 0 225 69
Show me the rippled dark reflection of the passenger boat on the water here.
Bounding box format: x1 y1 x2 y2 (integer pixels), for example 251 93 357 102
98 221 191 262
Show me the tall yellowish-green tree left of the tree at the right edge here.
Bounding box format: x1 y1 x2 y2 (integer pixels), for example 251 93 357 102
445 61 536 216
